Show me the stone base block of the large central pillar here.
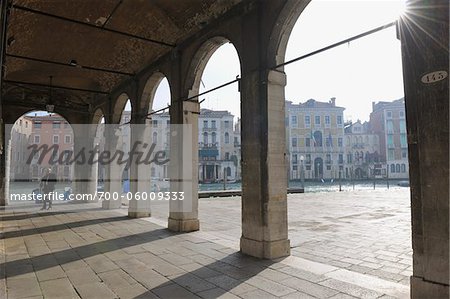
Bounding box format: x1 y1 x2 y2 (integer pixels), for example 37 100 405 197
241 237 291 259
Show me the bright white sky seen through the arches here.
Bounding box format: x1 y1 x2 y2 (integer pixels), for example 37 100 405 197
135 0 404 121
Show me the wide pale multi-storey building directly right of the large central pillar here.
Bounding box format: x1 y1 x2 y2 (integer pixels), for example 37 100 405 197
286 98 345 180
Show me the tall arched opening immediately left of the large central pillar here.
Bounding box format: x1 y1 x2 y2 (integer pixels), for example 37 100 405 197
191 37 241 191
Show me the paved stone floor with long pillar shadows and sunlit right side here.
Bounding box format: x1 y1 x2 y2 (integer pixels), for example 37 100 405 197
0 189 411 299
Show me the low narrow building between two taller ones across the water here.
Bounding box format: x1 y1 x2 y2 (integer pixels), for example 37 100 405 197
344 120 384 179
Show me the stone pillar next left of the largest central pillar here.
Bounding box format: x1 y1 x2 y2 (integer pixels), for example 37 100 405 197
168 101 200 232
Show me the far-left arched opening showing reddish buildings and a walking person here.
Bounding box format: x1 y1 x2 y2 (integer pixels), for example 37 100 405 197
5 111 75 207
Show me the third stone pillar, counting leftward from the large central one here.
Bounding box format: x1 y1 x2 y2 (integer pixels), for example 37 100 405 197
128 115 152 218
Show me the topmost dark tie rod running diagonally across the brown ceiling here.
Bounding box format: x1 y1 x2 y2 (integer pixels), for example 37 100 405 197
13 5 176 48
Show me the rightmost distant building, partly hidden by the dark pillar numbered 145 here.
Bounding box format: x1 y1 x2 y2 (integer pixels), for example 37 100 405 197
370 98 409 179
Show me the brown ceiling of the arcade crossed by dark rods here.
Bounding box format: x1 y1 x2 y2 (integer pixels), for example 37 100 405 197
3 0 241 111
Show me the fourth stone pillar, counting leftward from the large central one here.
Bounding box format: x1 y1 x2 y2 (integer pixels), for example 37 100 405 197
102 125 123 209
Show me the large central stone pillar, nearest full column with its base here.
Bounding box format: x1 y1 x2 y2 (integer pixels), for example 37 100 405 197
241 71 290 259
